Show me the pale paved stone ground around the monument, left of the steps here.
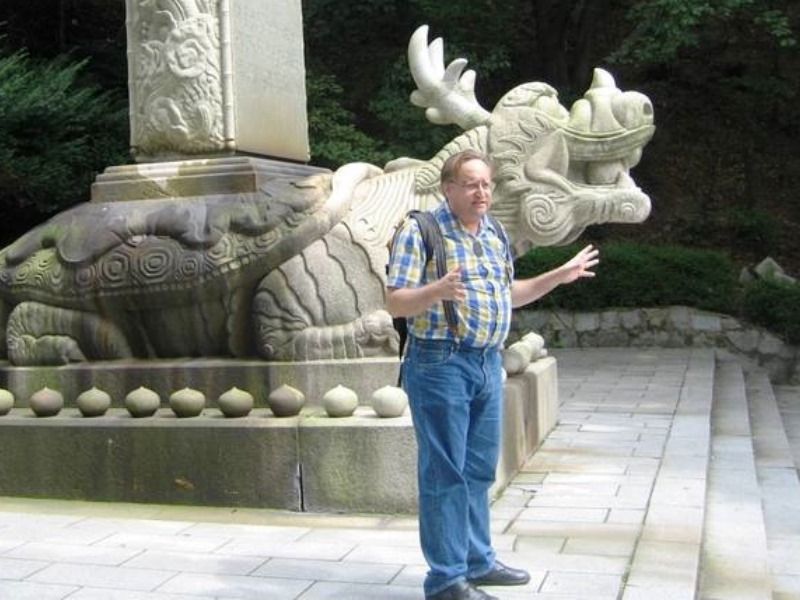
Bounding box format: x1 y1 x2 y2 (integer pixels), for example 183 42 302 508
0 349 793 600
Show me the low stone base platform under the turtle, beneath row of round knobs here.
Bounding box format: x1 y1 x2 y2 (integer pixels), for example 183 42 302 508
0 358 558 513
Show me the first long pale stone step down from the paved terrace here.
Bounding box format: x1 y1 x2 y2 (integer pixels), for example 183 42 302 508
698 360 772 600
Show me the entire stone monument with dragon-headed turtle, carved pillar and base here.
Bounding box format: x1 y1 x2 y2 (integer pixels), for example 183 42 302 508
0 16 654 512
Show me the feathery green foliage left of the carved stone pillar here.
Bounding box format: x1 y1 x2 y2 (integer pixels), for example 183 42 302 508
0 52 127 240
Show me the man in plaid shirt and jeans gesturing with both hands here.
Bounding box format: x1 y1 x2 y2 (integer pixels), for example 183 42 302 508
387 150 599 600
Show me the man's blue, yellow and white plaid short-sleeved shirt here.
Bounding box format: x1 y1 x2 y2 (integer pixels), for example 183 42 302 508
386 201 514 348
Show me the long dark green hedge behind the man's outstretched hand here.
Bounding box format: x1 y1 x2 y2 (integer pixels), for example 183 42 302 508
516 243 737 313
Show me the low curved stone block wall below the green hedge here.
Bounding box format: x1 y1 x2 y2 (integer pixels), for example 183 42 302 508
509 306 800 383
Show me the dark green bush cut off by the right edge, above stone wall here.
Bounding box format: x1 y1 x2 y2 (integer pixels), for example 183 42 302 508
742 279 800 344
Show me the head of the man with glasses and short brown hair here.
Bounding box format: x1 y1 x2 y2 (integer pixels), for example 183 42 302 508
444 159 492 233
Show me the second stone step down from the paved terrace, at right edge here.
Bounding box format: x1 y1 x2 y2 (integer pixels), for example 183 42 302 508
745 369 800 599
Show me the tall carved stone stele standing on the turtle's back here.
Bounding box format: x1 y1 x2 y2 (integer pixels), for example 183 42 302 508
126 0 309 161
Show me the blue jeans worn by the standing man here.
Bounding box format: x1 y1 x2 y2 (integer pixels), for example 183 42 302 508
403 337 503 596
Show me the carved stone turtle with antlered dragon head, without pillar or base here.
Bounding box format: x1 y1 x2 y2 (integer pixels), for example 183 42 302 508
0 26 655 365
